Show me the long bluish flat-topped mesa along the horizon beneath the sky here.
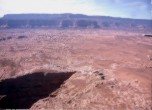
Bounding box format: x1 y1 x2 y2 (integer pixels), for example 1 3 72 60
0 14 152 30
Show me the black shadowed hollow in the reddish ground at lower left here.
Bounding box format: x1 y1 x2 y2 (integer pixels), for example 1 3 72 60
0 72 75 109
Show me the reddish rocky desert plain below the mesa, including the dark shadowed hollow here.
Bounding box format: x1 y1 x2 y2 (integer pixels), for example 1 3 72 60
0 29 152 110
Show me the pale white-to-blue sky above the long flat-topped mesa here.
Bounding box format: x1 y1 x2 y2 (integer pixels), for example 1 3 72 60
0 0 152 19
